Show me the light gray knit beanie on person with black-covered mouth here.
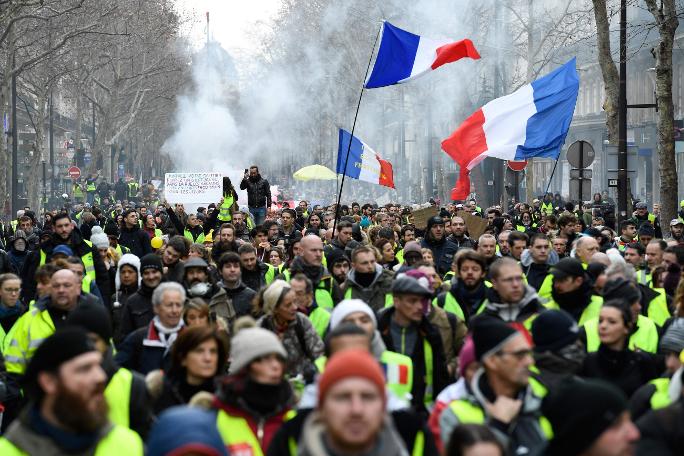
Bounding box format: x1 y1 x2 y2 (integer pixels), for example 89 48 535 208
228 328 287 375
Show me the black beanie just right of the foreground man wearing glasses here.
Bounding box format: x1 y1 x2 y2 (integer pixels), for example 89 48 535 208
532 310 579 353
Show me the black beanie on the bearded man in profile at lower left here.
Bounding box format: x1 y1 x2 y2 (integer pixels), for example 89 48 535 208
22 328 97 398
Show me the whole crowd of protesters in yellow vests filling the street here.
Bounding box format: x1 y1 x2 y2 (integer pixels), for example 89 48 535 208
0 166 684 456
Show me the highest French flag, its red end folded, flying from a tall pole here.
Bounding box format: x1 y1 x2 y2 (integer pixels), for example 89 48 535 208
365 21 480 89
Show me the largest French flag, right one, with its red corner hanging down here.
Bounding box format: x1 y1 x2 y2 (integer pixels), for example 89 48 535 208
442 58 579 200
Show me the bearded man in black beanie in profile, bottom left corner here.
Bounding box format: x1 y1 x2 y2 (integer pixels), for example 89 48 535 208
0 328 143 456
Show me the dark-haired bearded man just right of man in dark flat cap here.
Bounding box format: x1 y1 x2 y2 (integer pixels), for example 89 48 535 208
433 249 487 323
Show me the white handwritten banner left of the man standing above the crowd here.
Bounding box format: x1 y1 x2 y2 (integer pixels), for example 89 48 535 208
164 173 223 204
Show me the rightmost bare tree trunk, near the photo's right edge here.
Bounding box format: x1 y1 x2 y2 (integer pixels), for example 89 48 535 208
646 0 679 234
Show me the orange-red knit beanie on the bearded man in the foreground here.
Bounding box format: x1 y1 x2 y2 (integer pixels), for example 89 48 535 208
318 349 385 407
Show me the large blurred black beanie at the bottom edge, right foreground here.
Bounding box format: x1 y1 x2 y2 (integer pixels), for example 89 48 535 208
542 377 627 456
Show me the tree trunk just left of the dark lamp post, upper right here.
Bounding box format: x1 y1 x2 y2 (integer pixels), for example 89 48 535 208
592 0 620 144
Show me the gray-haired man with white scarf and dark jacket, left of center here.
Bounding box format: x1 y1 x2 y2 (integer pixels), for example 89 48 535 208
115 282 186 375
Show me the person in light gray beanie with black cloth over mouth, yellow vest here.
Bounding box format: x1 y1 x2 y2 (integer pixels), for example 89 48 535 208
213 326 296 455
